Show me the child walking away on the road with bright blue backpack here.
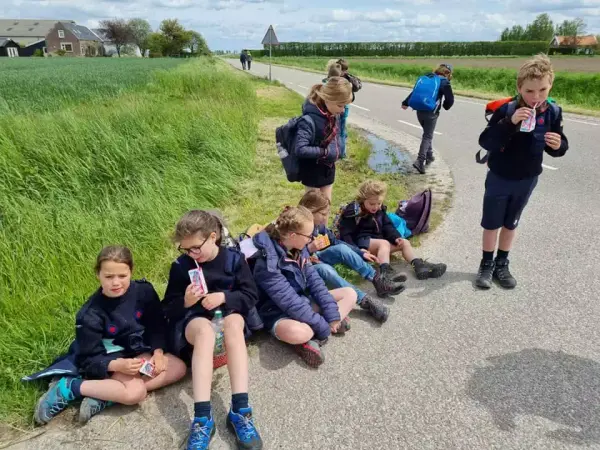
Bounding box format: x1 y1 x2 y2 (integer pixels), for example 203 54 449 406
402 64 454 174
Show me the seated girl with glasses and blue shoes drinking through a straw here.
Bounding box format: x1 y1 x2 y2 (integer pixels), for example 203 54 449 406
163 210 262 450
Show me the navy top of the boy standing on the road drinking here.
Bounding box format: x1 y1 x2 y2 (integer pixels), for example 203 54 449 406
479 103 569 180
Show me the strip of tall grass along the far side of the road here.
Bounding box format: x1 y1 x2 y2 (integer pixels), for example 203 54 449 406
255 57 600 110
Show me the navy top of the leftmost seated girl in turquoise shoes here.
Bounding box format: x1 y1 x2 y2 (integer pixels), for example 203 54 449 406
75 281 165 379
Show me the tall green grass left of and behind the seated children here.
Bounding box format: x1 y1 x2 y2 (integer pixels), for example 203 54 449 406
0 58 257 422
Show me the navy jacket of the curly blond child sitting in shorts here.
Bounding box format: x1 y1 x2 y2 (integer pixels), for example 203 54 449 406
339 202 402 250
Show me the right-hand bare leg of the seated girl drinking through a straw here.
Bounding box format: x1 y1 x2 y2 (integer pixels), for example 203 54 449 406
224 314 248 394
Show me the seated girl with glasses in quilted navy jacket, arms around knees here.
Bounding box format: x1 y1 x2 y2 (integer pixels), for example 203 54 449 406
253 206 356 367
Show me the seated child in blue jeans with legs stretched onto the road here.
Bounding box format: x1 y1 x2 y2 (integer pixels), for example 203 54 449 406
300 189 404 322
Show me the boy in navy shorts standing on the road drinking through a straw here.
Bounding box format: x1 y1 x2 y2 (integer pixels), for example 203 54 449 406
476 54 569 289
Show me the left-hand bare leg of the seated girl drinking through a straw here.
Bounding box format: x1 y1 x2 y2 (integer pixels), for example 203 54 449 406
185 317 215 402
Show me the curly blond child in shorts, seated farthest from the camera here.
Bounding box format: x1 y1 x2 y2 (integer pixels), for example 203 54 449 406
339 180 446 281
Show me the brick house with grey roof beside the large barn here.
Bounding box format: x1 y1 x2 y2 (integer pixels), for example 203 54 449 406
46 22 102 56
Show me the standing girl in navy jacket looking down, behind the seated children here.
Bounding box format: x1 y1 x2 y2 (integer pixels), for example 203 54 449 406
294 77 352 200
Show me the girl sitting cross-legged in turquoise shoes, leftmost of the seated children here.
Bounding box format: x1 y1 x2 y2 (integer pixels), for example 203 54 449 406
34 246 186 424
